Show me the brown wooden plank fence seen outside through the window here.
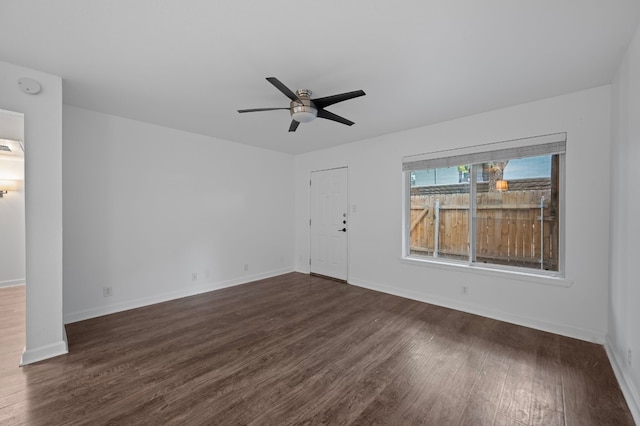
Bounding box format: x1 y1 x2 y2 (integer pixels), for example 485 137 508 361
410 189 558 270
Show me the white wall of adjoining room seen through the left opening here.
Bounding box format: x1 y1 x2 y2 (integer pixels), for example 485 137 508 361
0 151 25 287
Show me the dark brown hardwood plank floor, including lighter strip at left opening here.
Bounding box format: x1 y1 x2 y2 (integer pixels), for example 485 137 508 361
0 273 634 426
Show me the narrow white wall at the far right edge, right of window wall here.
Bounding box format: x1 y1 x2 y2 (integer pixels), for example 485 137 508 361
607 21 640 423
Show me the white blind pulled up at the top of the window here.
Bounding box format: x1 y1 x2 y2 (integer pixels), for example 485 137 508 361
402 133 567 171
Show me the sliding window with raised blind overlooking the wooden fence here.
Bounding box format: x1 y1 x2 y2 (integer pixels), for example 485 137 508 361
403 133 566 275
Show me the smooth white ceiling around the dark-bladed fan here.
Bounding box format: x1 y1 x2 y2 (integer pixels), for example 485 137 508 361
0 0 640 154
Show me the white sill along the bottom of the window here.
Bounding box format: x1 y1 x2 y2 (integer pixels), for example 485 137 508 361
401 256 573 288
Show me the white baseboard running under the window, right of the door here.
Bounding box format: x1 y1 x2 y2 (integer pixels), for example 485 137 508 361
349 278 605 344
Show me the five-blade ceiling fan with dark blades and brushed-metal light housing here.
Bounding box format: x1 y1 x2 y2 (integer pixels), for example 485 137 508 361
238 77 366 132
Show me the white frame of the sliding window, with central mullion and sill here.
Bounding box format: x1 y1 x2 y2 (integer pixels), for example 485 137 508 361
401 132 573 287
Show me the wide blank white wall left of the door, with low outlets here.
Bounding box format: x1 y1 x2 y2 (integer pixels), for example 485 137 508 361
63 105 294 322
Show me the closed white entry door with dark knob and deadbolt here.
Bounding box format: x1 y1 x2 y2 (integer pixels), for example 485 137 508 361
310 167 349 281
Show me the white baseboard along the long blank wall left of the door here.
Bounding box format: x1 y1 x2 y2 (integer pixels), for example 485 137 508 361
64 268 293 324
